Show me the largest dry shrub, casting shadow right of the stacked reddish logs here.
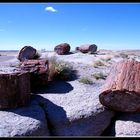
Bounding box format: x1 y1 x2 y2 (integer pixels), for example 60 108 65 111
49 56 74 80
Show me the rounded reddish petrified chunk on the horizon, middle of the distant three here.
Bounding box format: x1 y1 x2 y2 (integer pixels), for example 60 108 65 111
54 43 70 55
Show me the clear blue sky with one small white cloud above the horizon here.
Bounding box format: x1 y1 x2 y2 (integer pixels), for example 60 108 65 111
0 3 140 50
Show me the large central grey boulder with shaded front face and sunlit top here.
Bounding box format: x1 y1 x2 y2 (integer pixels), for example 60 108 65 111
34 81 114 136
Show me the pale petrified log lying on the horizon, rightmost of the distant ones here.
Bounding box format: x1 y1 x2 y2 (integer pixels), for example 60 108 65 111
76 44 97 53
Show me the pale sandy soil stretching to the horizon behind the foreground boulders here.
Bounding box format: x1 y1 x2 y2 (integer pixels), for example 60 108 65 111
0 50 140 80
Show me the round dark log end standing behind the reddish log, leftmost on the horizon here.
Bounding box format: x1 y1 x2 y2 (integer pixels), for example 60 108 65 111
18 46 37 61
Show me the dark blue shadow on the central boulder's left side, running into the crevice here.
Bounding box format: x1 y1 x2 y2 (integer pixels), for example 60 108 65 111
33 95 70 136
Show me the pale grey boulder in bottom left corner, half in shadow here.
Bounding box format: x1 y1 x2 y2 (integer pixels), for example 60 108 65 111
0 96 49 137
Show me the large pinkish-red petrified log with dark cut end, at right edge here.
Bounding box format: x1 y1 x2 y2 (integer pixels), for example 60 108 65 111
99 60 140 112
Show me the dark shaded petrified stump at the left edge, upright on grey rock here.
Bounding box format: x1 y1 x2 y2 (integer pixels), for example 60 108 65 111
0 72 30 109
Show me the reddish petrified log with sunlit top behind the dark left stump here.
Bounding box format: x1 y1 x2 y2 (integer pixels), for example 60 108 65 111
21 60 49 91
